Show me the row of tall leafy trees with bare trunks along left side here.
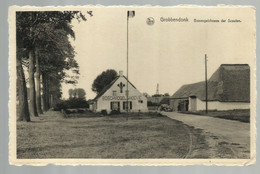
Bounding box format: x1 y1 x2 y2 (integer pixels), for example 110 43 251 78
16 11 86 121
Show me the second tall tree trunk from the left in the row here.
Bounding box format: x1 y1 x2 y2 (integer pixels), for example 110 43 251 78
29 51 38 117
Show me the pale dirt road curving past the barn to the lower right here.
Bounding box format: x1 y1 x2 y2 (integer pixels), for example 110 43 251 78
162 112 250 158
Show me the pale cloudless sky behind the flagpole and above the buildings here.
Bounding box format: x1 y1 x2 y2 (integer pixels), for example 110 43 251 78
62 7 255 99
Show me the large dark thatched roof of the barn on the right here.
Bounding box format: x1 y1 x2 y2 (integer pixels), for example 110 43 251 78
171 64 250 102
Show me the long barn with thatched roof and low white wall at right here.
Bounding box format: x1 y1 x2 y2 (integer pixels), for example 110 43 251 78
170 64 250 111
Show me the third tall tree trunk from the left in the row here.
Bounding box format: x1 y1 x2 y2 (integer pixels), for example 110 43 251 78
35 49 43 114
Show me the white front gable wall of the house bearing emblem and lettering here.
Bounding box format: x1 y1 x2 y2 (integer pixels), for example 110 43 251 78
96 76 148 113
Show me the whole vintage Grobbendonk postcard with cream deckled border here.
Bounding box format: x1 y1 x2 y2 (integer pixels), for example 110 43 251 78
9 5 256 166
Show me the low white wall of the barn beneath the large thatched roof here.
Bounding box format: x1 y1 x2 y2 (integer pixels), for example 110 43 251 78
196 98 250 111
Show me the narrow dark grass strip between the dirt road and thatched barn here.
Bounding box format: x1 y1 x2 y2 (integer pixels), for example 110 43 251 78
182 109 250 123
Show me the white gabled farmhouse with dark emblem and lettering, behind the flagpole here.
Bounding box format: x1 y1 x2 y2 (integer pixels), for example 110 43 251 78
90 71 148 113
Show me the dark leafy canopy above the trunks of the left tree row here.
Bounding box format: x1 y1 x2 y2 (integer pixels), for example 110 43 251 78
16 11 86 83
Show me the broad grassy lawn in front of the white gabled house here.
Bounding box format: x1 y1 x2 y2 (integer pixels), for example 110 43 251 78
17 111 201 159
